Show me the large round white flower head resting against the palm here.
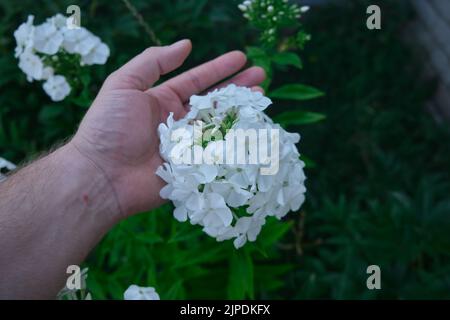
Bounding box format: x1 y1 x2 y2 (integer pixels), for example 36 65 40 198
156 84 306 248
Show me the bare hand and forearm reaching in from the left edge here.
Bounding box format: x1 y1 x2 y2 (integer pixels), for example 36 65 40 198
0 40 264 299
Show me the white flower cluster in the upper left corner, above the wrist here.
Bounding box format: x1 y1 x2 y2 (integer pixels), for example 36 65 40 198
14 14 109 101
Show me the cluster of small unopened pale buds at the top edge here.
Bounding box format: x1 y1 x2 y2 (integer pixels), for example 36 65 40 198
239 0 310 48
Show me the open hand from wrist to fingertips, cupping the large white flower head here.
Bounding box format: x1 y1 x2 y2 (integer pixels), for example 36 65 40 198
68 40 265 218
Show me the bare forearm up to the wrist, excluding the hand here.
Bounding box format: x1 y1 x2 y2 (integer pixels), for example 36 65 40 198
0 143 120 299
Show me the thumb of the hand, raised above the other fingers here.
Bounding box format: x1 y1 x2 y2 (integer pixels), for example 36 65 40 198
105 40 192 91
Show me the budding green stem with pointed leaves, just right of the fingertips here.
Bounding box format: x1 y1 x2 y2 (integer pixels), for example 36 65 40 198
243 0 325 148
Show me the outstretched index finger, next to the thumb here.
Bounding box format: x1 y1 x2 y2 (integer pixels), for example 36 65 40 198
155 51 247 102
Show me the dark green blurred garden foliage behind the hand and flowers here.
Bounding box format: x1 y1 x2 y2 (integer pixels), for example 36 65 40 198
0 0 450 299
